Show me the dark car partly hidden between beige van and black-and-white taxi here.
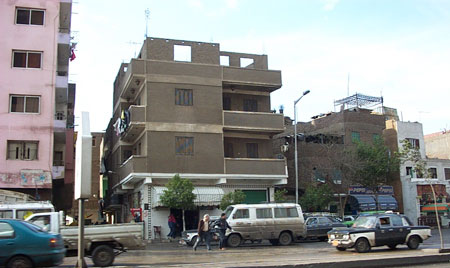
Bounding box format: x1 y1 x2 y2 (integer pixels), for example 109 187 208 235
306 216 347 241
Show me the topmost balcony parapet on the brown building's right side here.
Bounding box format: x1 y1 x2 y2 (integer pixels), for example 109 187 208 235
222 66 281 92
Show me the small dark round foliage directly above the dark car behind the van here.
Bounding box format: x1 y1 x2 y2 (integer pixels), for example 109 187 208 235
299 184 333 212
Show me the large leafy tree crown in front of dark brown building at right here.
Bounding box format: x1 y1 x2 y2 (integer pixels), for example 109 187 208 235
355 138 400 193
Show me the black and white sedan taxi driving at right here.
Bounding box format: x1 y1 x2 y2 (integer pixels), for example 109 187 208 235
328 213 431 253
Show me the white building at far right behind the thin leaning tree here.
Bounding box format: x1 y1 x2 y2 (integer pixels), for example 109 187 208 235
384 120 450 223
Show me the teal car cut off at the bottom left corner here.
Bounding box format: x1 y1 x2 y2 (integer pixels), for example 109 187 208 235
0 219 66 268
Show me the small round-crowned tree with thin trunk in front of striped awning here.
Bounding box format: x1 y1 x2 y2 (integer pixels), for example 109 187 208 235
160 174 196 231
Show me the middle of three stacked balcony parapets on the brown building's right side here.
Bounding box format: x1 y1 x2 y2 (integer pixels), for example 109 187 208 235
223 111 284 133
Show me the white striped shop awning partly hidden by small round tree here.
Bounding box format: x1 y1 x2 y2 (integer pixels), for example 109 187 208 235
152 186 224 208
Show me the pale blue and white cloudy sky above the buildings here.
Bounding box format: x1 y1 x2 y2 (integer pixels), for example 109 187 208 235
69 0 450 134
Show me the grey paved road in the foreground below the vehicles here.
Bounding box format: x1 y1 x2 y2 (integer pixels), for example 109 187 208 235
63 229 450 268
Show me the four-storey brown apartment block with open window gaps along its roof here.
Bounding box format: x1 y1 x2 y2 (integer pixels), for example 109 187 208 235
104 37 287 239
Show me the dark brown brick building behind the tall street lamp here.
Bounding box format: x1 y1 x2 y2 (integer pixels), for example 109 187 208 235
274 107 394 213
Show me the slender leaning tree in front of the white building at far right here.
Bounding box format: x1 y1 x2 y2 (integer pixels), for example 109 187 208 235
399 139 444 249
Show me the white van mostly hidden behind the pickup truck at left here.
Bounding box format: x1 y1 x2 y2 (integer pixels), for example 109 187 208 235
0 201 55 220
